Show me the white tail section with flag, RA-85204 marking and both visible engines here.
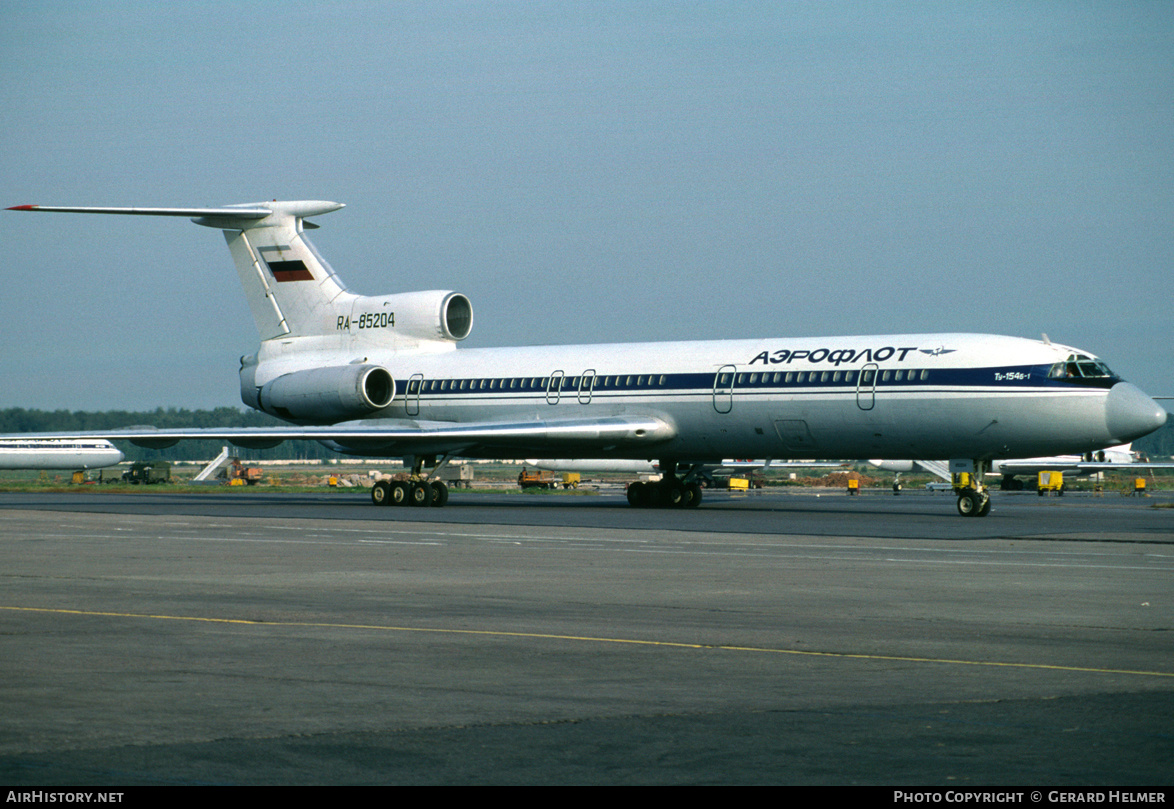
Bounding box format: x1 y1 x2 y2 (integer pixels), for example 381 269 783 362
9 200 473 424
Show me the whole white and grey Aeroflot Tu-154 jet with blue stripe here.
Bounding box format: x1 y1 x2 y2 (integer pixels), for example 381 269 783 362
11 201 1166 517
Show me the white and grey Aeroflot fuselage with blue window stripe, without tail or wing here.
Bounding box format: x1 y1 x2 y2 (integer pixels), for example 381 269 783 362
261 333 1165 460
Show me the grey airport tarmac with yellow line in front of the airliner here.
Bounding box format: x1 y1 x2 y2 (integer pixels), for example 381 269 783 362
0 490 1174 789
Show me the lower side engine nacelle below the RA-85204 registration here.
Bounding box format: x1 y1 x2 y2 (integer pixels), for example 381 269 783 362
241 365 396 423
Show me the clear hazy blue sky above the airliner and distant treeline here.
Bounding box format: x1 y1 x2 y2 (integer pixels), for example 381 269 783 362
0 0 1174 410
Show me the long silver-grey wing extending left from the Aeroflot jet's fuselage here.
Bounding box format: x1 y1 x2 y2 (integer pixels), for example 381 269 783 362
0 416 676 456
